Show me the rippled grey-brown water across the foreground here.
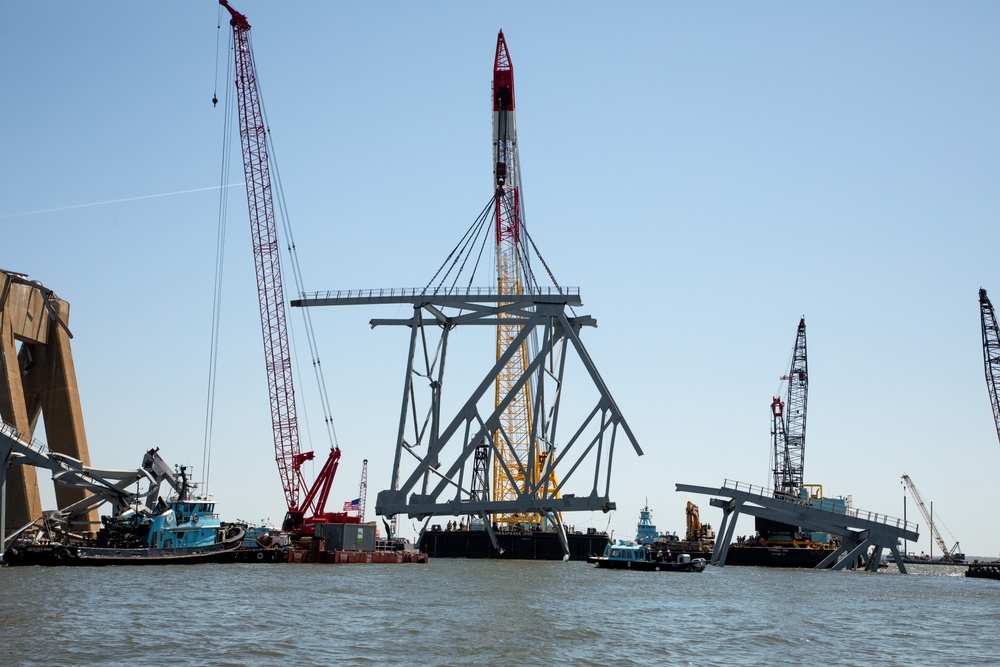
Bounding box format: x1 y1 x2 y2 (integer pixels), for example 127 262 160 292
0 559 1000 667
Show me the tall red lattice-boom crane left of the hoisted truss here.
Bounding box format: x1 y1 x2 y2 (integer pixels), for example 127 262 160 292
219 0 360 534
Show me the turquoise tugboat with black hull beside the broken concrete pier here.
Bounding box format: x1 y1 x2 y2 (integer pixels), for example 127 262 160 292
3 450 245 566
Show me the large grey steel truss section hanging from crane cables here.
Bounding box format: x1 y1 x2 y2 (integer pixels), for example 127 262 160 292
292 288 642 527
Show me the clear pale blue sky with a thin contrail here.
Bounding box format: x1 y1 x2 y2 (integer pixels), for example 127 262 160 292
0 0 1000 557
